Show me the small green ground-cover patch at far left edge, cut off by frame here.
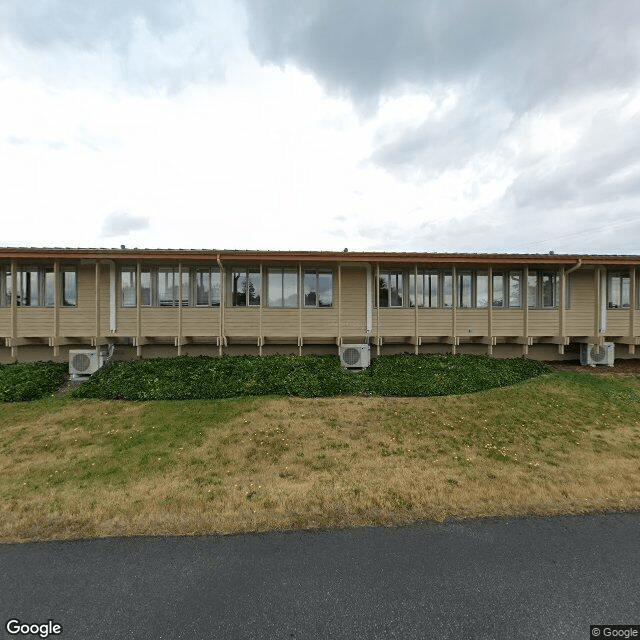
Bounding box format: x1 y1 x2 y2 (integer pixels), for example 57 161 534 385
0 362 69 402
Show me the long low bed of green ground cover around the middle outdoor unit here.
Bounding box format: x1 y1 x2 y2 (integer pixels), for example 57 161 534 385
70 355 551 400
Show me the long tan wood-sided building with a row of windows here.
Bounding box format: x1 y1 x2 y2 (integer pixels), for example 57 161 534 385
0 247 640 363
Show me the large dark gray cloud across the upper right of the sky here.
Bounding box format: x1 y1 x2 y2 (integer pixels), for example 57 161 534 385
245 0 640 113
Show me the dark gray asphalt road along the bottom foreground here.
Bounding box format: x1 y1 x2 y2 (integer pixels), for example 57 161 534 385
0 513 640 640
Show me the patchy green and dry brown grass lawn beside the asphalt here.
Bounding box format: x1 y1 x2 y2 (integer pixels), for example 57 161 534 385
0 373 640 541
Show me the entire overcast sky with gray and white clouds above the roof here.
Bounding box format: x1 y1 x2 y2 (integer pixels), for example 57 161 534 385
0 0 640 254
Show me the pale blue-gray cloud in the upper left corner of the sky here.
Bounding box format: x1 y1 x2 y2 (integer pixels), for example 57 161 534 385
0 0 243 91
